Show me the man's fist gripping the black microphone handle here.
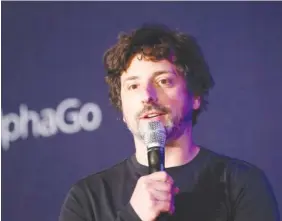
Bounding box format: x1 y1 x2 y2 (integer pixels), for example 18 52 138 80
130 171 179 221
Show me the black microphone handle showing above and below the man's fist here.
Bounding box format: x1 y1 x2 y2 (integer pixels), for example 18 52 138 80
147 147 168 221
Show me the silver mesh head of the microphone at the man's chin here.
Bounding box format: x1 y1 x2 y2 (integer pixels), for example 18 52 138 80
144 121 166 148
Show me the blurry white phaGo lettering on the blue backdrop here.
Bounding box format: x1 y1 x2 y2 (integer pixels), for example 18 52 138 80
1 98 102 150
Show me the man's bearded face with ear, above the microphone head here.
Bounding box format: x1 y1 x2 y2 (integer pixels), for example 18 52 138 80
121 55 200 140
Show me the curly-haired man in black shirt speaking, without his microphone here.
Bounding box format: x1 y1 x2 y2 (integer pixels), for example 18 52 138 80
60 25 279 221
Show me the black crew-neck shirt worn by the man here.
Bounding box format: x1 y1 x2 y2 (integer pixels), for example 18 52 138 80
59 147 279 221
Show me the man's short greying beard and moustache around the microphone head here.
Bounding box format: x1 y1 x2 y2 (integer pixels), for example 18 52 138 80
127 103 192 143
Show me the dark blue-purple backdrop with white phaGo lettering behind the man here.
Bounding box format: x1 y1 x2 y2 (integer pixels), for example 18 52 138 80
1 2 282 221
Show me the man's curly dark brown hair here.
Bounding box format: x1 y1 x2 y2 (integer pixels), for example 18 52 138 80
103 24 214 125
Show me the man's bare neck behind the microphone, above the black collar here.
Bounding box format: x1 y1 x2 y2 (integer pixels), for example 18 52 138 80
134 126 200 168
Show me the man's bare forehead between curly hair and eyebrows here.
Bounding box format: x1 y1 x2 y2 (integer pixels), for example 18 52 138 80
121 55 175 78
